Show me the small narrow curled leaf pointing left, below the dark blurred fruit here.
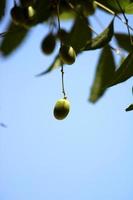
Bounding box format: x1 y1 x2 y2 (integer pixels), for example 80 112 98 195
36 55 61 77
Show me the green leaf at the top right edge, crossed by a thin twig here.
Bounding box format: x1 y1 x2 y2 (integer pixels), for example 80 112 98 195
97 0 130 14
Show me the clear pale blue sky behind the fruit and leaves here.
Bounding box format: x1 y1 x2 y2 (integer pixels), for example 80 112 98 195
0 2 133 200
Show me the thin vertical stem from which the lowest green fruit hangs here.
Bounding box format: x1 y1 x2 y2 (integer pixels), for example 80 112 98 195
57 0 67 99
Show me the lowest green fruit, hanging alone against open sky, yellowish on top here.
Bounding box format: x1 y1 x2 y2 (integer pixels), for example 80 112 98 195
54 98 70 120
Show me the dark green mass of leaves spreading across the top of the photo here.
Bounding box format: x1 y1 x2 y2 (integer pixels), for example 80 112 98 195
0 0 133 111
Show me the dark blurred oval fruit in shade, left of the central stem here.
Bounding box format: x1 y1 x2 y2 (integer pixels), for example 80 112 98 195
41 33 56 55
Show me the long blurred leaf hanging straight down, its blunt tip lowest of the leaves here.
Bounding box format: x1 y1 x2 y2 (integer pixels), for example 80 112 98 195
89 45 115 103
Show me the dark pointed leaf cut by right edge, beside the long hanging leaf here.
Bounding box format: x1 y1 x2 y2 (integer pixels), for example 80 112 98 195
109 52 133 86
